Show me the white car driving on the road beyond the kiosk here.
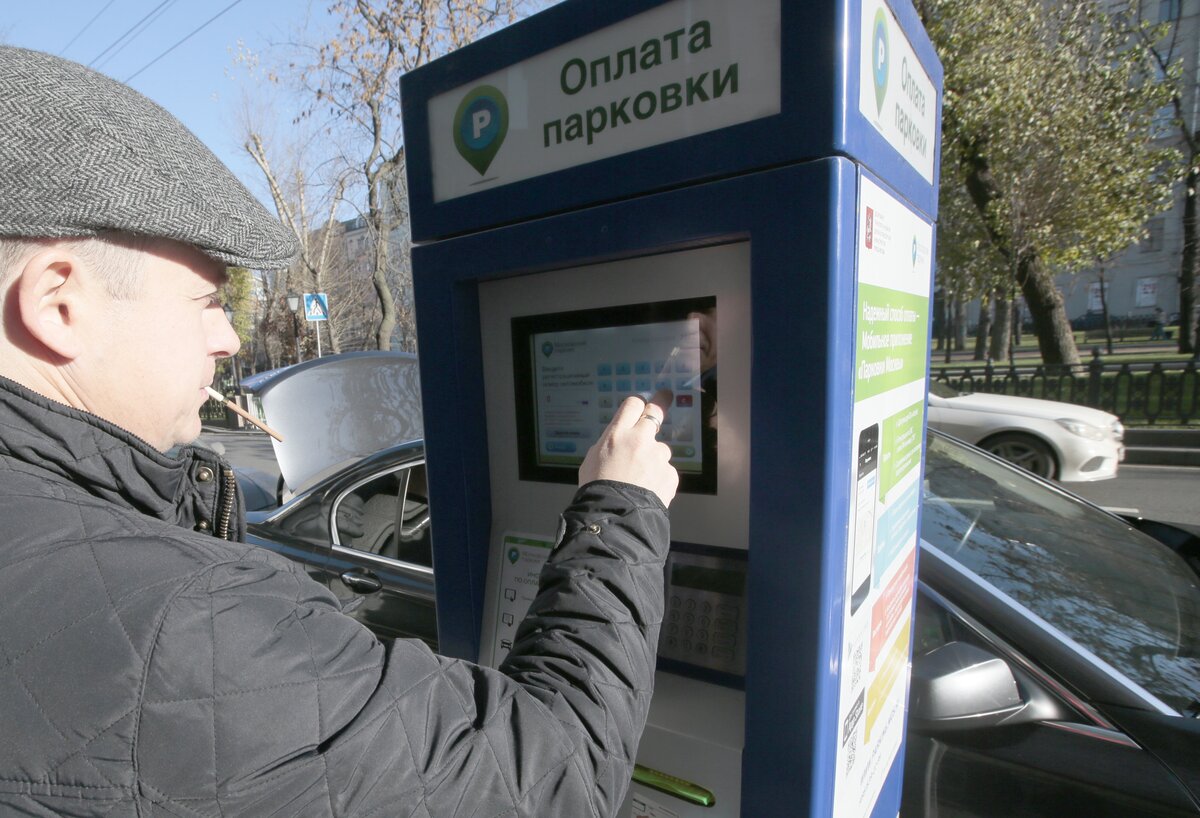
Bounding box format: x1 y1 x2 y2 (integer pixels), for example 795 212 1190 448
929 380 1124 482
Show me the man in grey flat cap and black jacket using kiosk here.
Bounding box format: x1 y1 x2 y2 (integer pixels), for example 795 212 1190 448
0 47 678 818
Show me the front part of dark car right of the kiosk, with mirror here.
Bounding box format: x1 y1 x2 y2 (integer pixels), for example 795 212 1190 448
902 433 1200 818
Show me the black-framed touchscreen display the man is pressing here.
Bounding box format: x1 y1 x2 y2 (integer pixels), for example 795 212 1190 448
512 297 716 492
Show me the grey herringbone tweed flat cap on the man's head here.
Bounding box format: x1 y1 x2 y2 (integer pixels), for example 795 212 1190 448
0 46 296 270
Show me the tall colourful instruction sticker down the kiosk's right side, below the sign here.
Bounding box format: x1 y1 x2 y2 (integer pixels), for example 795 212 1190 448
833 173 934 818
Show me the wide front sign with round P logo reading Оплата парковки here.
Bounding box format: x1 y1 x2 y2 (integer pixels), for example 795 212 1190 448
428 0 781 202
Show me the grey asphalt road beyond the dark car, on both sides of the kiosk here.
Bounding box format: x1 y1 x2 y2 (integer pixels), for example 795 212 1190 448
199 431 1200 525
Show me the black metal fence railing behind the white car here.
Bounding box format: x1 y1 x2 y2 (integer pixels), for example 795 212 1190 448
932 357 1200 426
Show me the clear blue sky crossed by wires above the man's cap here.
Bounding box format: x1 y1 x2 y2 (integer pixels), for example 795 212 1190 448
0 0 330 211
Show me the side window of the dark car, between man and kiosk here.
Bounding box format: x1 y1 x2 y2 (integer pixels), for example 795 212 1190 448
334 463 433 567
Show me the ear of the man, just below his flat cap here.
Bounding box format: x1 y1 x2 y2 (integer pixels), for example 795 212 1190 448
16 247 94 361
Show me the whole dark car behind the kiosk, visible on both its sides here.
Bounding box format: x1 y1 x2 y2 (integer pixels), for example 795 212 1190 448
236 355 1200 818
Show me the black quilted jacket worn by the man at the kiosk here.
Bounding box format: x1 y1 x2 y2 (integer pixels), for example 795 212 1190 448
0 379 668 818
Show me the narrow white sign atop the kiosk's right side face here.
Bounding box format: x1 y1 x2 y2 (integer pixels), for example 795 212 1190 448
858 0 937 185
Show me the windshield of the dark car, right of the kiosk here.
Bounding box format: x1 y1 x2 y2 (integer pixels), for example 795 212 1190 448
922 433 1200 715
